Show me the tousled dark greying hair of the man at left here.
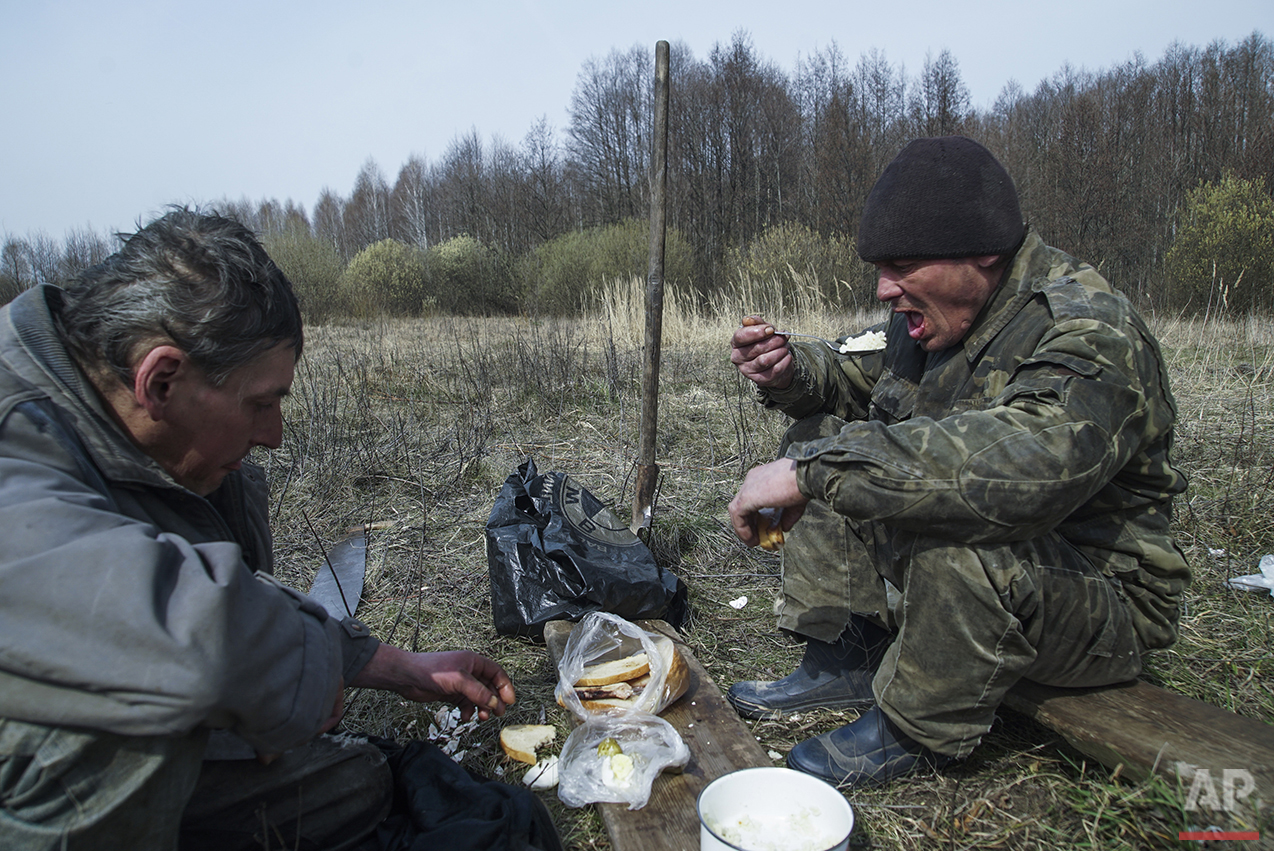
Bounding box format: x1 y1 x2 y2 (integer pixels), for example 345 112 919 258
57 208 303 386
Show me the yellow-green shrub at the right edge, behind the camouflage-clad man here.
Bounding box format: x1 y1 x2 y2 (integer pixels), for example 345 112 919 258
1167 175 1274 312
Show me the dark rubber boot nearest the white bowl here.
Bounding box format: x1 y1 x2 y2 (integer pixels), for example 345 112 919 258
787 706 956 787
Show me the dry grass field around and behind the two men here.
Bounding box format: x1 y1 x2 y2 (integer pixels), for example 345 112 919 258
260 282 1274 850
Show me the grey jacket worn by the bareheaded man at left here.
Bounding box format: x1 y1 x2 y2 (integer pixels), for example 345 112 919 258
0 287 377 752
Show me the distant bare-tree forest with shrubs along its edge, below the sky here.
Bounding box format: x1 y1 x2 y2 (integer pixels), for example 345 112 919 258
0 32 1274 318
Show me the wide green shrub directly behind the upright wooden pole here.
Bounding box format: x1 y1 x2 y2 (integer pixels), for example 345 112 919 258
519 219 694 316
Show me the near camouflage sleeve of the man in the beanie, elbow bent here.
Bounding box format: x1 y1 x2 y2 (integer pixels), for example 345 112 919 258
789 318 1161 543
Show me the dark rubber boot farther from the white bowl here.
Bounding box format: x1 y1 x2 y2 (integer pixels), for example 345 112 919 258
726 614 892 719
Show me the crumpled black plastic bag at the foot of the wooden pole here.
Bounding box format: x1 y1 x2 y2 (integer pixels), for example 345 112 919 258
487 459 688 638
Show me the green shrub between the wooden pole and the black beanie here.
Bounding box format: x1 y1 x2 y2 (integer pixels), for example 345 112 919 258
725 222 873 310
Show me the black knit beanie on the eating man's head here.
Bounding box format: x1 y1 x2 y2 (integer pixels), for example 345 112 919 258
859 136 1026 262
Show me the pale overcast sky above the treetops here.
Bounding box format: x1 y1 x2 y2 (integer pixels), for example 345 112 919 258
0 0 1274 240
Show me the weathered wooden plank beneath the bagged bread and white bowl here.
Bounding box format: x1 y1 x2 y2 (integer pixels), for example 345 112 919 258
544 620 773 851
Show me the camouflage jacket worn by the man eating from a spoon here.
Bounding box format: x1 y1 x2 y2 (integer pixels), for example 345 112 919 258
762 233 1190 647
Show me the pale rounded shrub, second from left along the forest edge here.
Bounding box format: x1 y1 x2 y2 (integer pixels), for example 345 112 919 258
340 240 433 317
